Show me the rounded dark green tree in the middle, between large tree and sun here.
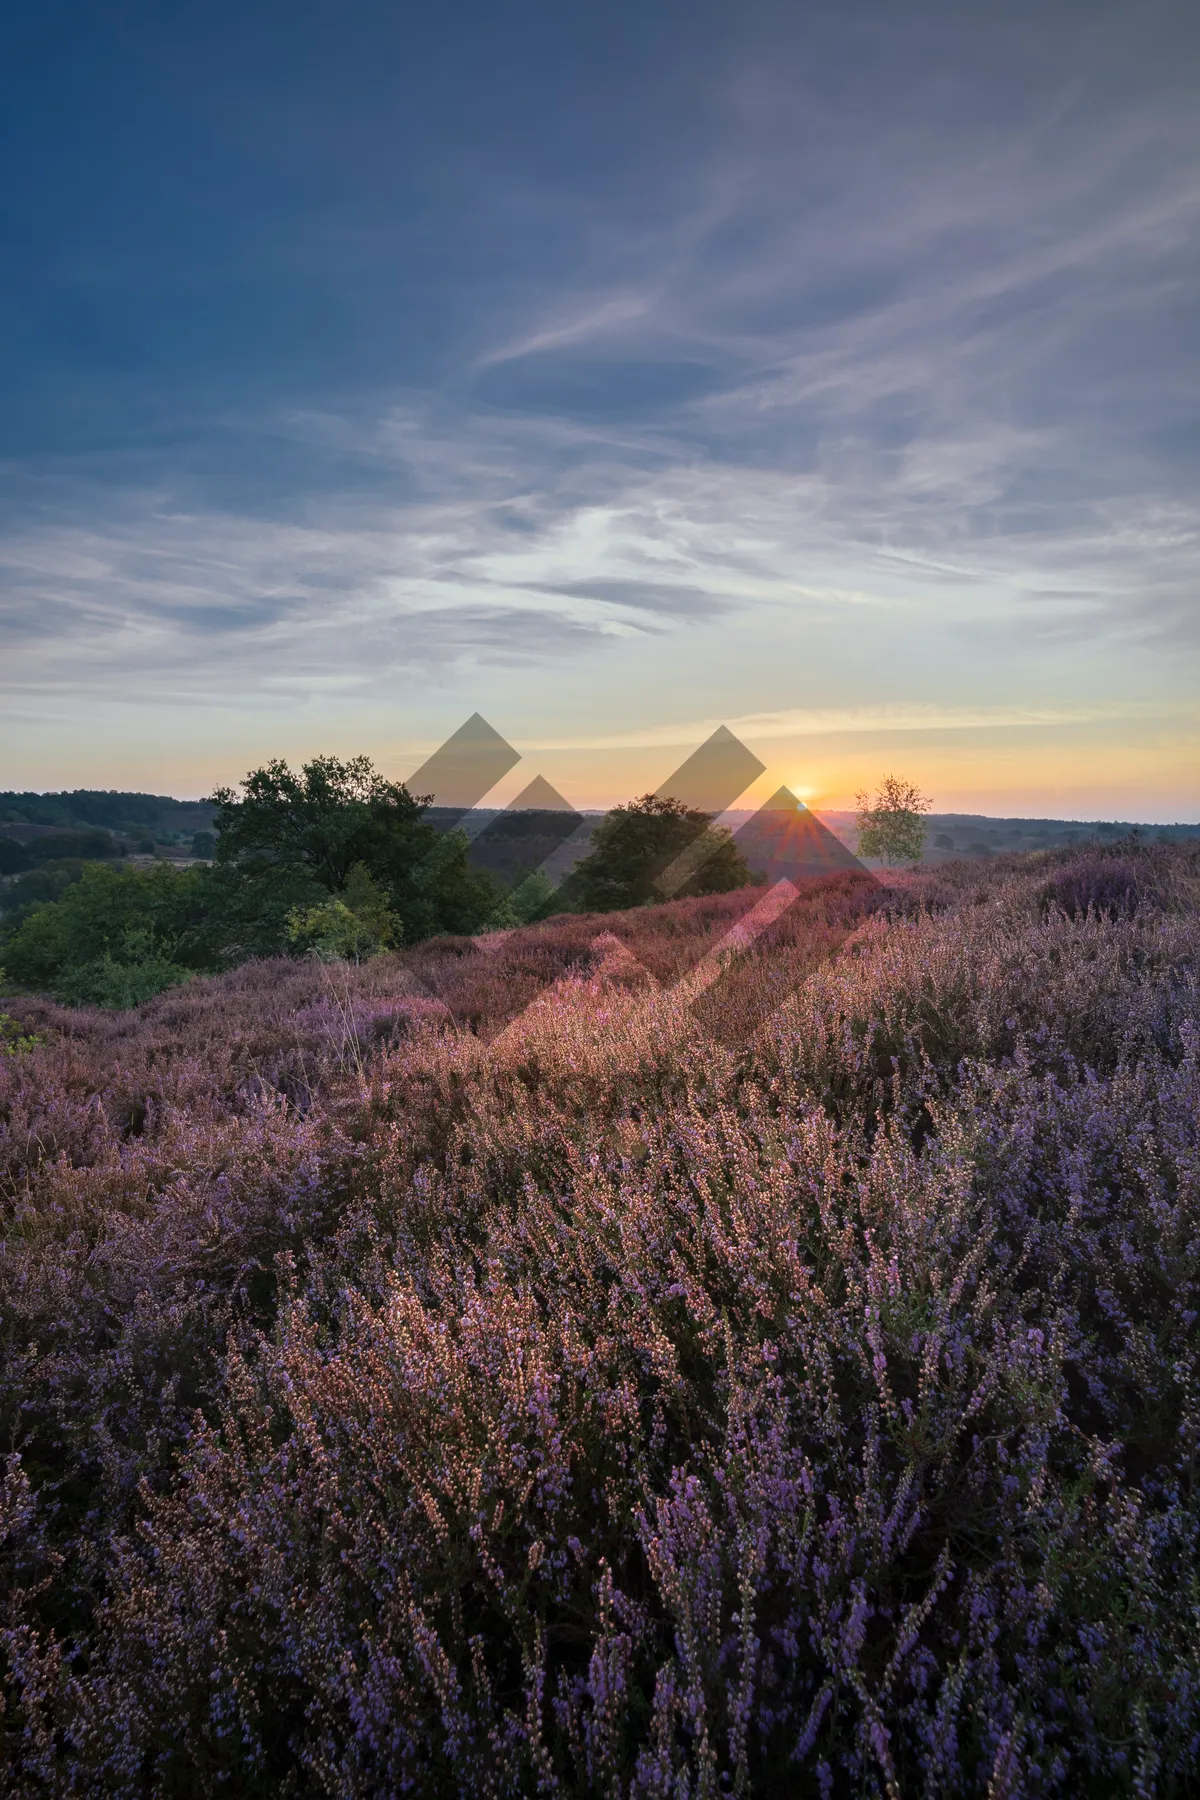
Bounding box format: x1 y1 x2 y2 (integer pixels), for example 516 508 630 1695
563 794 750 913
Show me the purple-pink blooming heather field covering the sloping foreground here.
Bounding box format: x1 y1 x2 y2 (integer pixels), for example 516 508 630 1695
0 842 1200 1800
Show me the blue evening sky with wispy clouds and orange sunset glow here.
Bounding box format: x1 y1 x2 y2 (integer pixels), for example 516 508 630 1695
0 0 1200 821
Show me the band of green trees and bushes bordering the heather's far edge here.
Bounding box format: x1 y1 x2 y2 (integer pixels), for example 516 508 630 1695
0 756 752 1006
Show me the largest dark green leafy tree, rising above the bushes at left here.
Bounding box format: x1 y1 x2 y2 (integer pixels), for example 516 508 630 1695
210 756 498 947
